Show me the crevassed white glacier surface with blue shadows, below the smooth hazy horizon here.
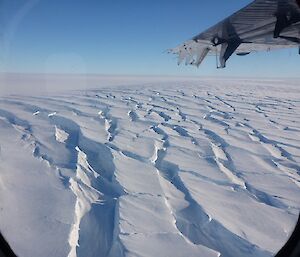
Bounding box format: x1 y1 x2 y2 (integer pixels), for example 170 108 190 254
0 80 300 257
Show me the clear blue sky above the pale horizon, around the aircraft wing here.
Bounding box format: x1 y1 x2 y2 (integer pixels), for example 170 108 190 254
0 0 300 77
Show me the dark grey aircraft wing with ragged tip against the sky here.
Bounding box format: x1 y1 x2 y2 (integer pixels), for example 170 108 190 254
169 0 300 68
